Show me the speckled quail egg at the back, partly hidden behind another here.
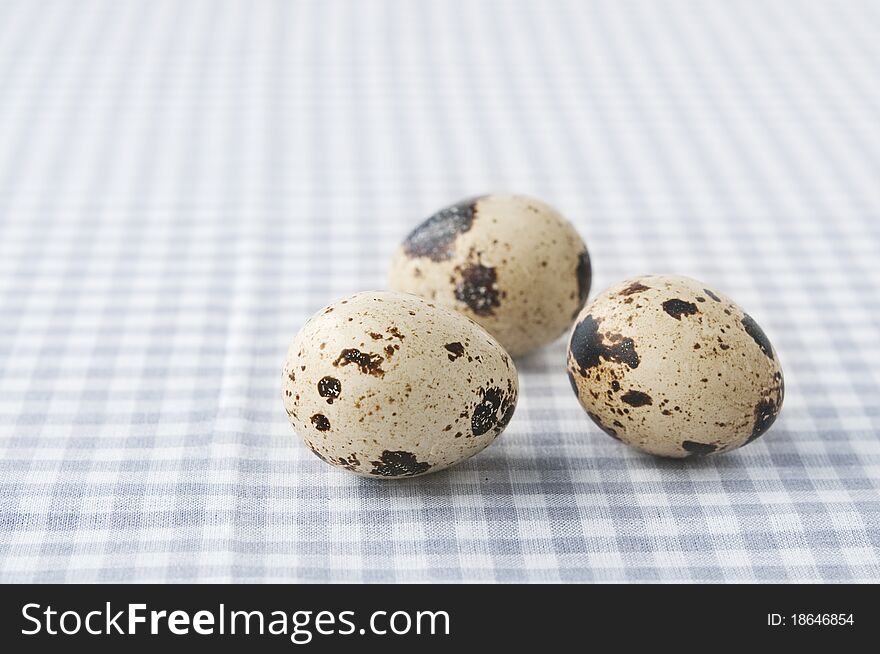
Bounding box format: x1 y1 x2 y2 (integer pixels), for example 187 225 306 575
389 194 591 356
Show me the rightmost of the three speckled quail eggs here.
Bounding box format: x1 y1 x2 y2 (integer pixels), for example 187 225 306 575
568 275 784 457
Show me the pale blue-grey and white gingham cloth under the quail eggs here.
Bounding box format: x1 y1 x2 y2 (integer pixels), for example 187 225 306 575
0 0 880 582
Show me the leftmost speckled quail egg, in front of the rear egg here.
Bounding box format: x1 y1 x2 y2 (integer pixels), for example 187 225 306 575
282 291 518 478
